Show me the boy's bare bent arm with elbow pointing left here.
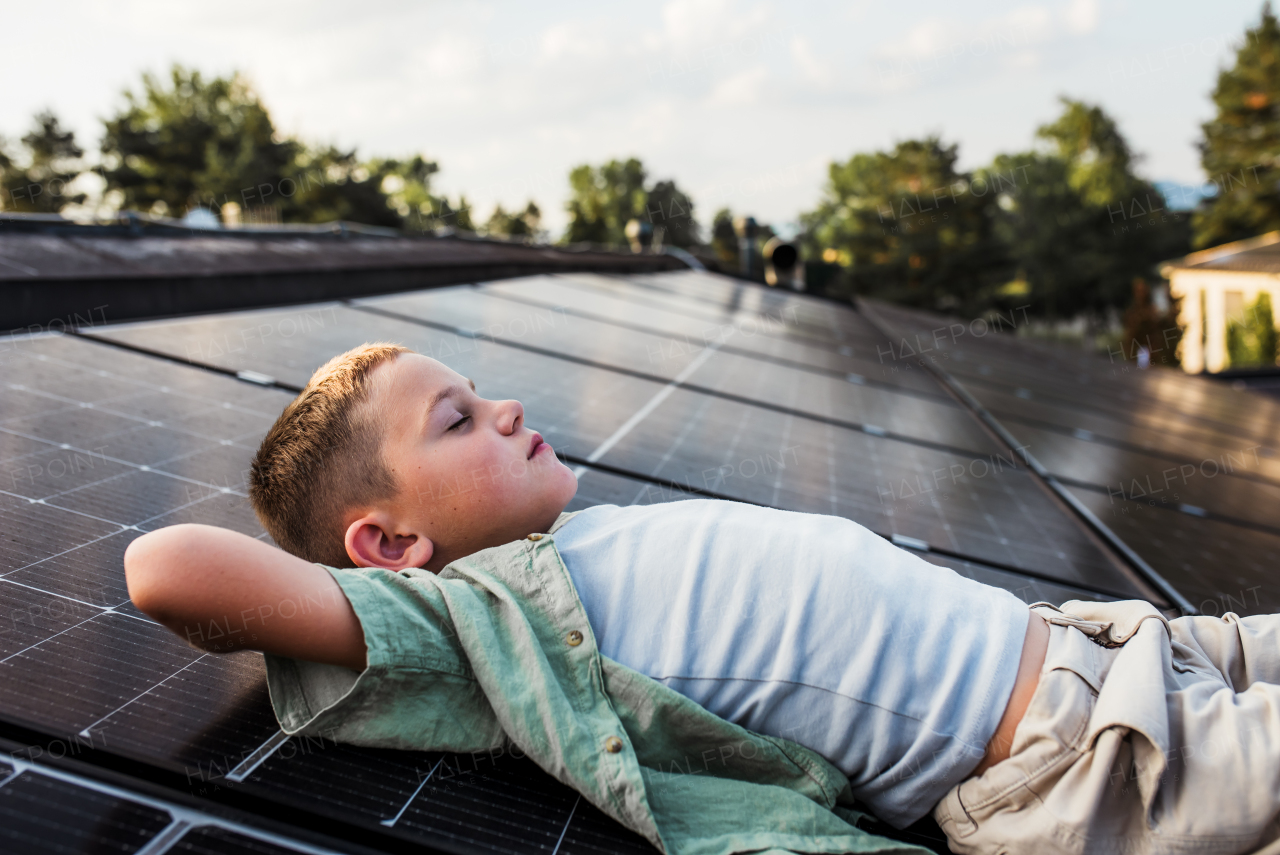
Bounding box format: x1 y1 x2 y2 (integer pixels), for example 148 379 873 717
124 523 366 671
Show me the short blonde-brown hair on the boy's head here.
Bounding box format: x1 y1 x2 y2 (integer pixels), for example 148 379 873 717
248 342 412 567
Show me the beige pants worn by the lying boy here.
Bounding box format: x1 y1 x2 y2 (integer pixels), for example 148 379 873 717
933 602 1280 855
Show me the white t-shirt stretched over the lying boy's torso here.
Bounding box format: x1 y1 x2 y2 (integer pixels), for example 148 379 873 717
554 500 1029 827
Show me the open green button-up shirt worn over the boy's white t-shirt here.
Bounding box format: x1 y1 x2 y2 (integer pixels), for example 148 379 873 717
266 513 927 855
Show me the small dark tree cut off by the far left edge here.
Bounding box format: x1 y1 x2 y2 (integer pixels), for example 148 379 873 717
0 110 86 214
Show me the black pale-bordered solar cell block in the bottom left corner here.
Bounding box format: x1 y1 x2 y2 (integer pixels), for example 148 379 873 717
0 772 170 855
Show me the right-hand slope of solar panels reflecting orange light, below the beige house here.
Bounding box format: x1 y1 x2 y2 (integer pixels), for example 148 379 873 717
860 296 1280 613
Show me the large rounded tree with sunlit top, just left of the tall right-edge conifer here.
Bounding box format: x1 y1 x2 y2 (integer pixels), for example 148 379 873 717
975 97 1188 317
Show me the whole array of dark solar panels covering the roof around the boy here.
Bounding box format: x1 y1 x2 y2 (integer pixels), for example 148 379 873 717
0 271 1280 855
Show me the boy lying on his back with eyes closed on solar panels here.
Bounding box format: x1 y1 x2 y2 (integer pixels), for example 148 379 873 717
124 344 1280 855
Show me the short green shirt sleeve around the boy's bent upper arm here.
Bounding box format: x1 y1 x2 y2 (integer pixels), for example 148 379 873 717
265 567 504 751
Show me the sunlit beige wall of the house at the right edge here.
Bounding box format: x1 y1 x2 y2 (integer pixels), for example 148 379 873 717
1169 270 1280 374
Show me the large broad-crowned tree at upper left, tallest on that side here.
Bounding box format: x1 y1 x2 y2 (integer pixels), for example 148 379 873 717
101 64 301 216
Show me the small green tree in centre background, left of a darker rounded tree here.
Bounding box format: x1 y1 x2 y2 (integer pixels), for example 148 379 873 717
564 157 648 246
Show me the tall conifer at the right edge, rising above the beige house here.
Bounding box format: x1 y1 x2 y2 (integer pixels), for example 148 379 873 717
1193 3 1280 247
